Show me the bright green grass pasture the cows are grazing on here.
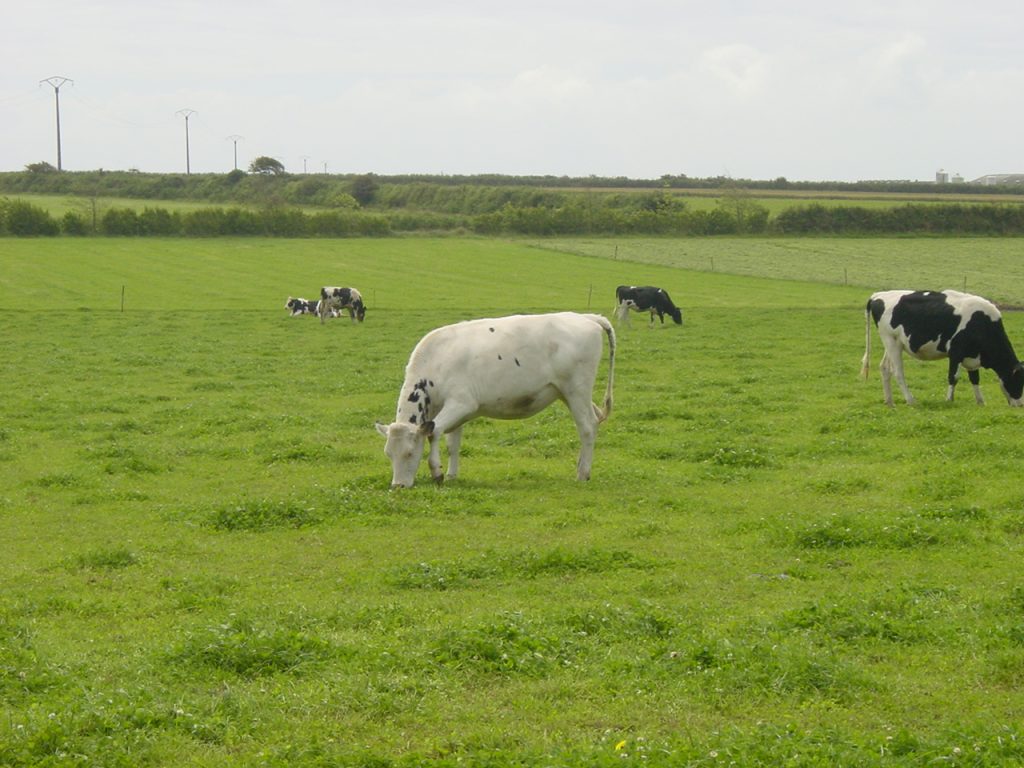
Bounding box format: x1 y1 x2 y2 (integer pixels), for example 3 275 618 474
0 239 1024 767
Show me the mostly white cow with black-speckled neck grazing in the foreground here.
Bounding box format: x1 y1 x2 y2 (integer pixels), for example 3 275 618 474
377 312 615 487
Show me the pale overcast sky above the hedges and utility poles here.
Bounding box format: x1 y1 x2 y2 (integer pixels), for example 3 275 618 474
0 0 1024 181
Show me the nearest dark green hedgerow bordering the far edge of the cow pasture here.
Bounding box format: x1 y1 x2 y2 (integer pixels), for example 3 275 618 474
6 195 1024 238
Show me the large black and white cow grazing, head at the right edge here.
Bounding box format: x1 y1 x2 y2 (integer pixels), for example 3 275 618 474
860 291 1024 407
